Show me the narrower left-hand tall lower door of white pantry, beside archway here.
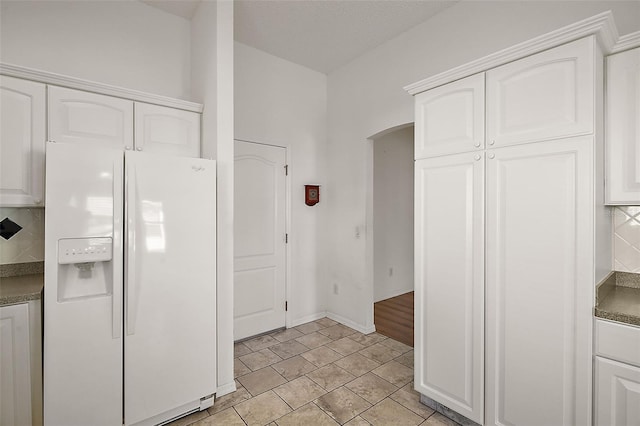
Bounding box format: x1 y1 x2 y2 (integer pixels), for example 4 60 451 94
415 153 485 423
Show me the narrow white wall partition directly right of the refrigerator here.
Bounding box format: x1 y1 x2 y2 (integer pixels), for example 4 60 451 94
191 0 236 397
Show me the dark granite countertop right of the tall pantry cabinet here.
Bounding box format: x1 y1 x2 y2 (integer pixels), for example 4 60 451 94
595 272 640 326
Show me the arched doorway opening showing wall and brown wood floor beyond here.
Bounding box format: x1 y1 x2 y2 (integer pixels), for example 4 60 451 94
367 123 414 346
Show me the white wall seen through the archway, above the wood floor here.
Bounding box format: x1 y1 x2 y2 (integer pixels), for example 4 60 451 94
373 126 413 302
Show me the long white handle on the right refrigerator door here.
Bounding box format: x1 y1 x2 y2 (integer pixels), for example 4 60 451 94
125 162 136 336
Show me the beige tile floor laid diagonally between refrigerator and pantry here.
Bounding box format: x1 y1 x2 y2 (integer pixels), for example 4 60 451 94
170 318 456 426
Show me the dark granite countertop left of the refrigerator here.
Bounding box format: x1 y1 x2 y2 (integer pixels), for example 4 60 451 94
0 262 44 306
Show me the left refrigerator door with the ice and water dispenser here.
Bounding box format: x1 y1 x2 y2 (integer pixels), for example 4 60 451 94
44 143 123 426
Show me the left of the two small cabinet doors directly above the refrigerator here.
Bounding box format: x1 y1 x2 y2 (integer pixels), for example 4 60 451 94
49 86 133 149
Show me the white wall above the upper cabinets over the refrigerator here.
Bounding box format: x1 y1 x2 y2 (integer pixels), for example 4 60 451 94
0 1 190 99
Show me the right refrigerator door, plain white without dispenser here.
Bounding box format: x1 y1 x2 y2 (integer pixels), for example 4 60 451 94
125 152 216 425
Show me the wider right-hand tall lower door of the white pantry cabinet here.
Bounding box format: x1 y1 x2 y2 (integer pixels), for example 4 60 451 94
485 137 594 425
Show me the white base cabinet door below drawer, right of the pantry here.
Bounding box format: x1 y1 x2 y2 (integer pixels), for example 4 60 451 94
595 357 640 426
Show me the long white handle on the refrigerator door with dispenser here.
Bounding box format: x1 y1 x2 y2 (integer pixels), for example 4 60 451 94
111 160 123 339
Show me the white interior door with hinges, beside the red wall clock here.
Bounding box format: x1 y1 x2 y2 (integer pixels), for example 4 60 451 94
233 141 286 340
